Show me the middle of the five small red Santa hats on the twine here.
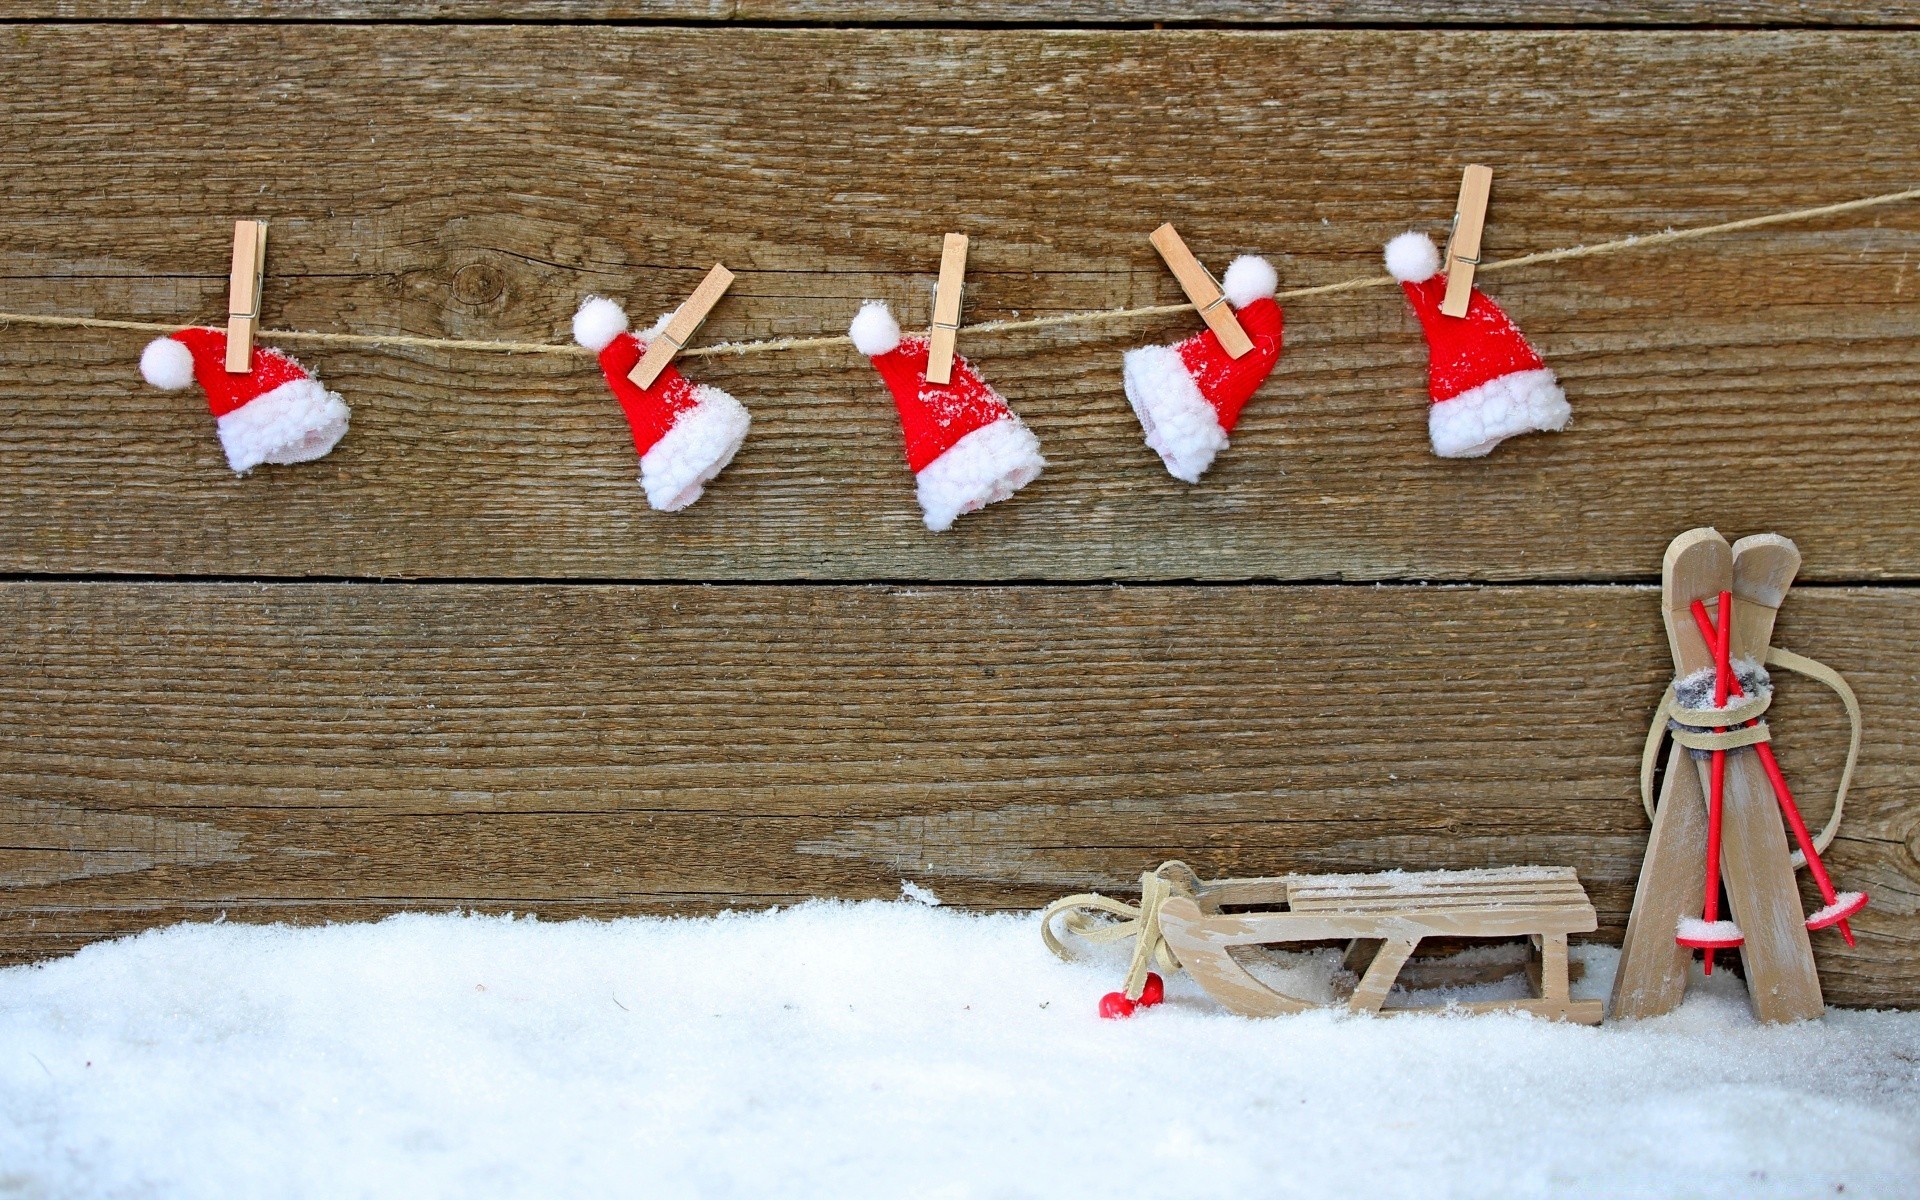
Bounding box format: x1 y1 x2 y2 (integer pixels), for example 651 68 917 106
847 300 1046 530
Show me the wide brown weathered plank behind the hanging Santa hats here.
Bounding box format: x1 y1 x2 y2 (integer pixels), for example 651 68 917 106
0 29 1920 582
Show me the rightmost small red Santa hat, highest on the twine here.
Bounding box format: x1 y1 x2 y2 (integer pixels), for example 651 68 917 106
1386 232 1572 459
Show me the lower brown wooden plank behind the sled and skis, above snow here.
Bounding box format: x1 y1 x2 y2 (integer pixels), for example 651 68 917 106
0 582 1920 1004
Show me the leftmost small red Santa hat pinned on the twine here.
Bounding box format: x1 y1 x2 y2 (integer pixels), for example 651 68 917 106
140 328 349 474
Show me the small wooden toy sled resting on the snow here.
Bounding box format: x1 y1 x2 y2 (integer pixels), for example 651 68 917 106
1043 862 1601 1025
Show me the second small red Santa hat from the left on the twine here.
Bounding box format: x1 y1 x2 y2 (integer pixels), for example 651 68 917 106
574 296 751 513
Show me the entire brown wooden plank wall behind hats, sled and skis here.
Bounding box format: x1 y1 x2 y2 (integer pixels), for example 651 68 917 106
0 0 1920 1006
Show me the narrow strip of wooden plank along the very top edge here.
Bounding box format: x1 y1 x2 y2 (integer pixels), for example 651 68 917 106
6 0 1914 27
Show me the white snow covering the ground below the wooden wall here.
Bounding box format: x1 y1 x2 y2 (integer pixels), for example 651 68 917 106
0 900 1920 1200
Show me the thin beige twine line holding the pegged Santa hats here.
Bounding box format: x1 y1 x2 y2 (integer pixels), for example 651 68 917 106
0 188 1920 359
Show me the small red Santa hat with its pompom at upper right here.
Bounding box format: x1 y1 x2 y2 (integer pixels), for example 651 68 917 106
1121 253 1281 484
